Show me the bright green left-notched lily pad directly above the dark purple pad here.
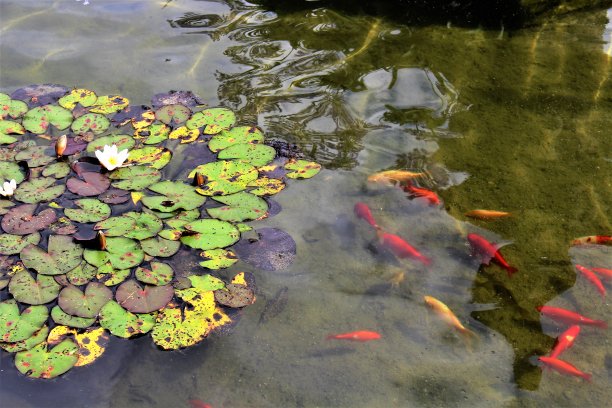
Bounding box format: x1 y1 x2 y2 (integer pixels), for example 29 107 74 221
206 191 268 222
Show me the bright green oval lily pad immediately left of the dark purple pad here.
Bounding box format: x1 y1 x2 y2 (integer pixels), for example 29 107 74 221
181 219 240 249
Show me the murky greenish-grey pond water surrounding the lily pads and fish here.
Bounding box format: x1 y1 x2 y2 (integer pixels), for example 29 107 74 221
0 0 612 407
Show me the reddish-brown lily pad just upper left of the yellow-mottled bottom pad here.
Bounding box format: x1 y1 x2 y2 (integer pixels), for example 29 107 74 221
115 280 174 313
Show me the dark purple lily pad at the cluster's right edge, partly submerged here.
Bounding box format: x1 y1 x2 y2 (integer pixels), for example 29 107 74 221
232 228 297 271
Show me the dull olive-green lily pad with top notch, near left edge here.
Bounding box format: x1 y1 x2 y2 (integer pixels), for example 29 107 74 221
9 270 61 305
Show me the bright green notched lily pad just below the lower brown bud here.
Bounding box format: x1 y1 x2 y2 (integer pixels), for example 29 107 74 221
83 237 144 269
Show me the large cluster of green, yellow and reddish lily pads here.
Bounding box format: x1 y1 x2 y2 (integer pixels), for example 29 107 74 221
0 85 320 378
